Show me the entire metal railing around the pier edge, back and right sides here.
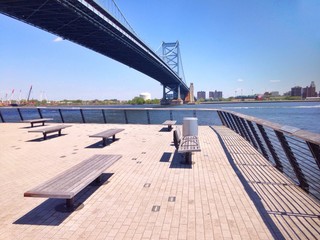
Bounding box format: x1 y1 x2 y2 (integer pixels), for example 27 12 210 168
0 107 320 200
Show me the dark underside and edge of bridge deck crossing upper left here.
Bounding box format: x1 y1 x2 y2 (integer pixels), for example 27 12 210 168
0 0 189 98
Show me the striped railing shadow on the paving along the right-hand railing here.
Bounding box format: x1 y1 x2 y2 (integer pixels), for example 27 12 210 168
214 126 320 239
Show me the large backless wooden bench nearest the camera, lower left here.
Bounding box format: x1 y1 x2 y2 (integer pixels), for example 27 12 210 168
24 155 122 209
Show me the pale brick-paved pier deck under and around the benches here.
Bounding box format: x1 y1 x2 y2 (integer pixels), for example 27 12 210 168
0 123 320 239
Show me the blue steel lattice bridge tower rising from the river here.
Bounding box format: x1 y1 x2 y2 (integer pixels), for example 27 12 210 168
157 41 185 104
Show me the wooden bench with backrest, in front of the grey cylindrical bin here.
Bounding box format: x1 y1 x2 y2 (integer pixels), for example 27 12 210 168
173 128 201 164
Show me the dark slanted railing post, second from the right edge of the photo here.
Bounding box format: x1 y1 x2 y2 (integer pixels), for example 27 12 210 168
274 130 309 192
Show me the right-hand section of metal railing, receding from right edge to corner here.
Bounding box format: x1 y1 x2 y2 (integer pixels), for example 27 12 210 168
217 110 320 199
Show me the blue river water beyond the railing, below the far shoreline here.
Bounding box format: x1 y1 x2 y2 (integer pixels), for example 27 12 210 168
0 102 320 133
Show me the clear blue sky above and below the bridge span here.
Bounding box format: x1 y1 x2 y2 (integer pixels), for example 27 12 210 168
0 0 320 100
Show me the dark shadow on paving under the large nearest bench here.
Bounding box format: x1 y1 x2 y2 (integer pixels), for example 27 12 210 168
13 173 113 226
